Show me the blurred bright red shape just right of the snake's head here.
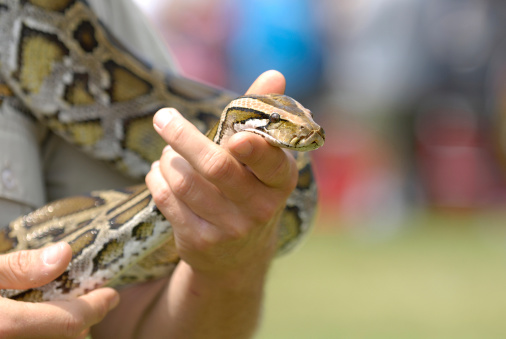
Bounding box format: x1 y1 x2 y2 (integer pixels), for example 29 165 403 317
312 118 402 226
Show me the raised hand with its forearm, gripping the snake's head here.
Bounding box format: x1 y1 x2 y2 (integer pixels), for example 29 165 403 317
92 71 298 339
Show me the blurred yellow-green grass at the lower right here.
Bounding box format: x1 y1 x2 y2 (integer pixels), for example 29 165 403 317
256 214 506 339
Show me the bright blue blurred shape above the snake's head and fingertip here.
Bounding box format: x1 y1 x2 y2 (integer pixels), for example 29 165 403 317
227 0 323 96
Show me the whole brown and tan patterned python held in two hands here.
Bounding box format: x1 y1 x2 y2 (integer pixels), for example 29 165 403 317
0 0 324 302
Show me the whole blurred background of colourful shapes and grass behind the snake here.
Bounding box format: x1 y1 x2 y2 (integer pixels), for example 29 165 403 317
136 0 506 339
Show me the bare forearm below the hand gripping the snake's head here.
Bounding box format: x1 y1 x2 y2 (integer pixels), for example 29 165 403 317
137 262 267 339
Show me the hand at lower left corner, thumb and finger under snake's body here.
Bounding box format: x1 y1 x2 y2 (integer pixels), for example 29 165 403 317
0 243 119 338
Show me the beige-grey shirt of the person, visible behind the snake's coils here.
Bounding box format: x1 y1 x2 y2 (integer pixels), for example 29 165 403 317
0 0 176 227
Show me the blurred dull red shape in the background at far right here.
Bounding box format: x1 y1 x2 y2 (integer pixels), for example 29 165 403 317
416 101 494 209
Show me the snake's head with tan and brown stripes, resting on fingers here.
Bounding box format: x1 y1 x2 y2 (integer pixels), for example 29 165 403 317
214 94 325 151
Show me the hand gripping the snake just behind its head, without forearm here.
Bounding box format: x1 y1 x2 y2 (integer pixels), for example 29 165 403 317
146 71 297 275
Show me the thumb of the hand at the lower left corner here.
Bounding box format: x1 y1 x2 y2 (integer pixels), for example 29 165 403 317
0 242 72 290
